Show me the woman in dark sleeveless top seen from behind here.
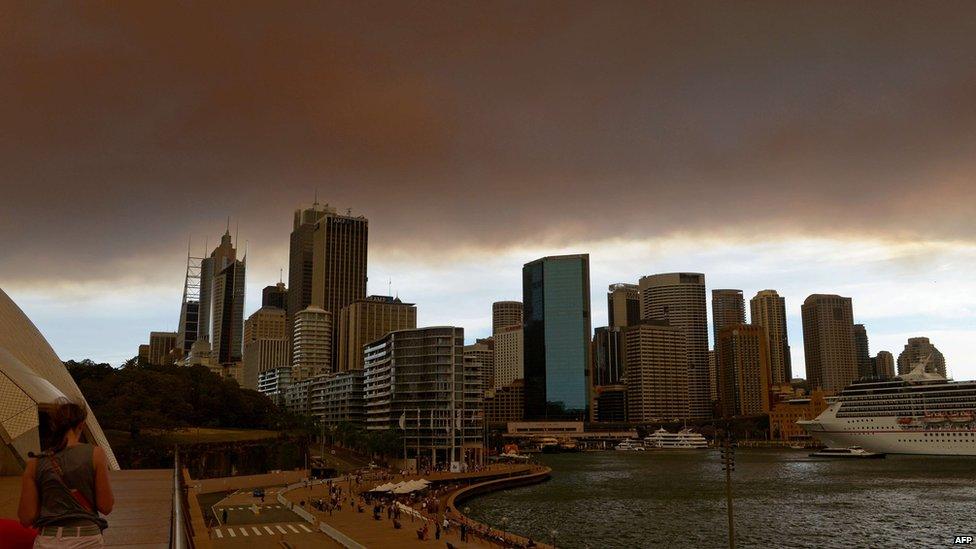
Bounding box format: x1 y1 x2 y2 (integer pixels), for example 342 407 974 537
17 399 115 549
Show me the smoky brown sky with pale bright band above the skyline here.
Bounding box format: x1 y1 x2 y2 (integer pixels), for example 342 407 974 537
0 1 976 379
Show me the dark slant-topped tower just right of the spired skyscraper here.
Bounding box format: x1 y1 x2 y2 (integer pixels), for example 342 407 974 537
210 254 247 364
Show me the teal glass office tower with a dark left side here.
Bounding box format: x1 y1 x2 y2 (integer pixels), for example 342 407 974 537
522 254 590 420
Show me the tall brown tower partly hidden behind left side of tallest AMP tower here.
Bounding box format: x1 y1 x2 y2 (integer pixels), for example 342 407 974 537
285 202 327 341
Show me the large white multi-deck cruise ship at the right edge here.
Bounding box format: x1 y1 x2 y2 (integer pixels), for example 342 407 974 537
797 360 976 456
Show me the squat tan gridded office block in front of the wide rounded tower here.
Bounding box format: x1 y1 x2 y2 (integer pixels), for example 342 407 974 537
621 318 692 422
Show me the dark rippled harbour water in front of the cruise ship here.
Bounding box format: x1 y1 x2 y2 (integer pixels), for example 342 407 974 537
465 448 976 548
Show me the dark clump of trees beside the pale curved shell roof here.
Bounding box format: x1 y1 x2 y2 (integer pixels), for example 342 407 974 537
65 359 284 437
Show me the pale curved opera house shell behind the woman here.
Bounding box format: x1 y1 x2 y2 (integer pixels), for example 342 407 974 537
0 289 119 476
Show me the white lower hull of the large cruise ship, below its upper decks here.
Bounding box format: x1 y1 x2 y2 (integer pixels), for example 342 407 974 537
798 403 976 456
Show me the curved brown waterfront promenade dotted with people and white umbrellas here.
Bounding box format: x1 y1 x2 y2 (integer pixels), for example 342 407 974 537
281 465 549 548
